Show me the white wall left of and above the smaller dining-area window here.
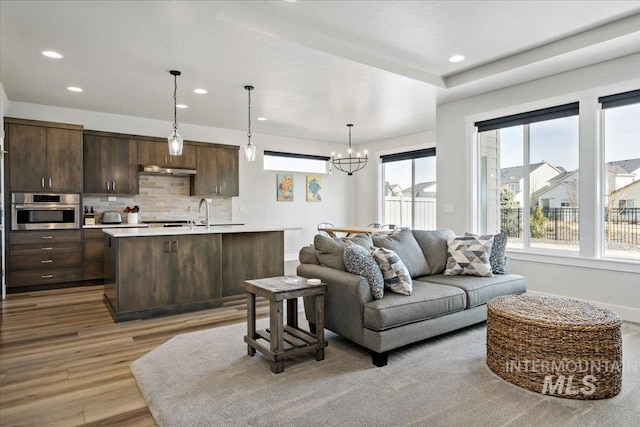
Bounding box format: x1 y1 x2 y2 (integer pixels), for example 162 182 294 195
352 130 436 226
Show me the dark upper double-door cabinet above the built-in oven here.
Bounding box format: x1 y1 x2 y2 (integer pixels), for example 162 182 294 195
4 117 83 193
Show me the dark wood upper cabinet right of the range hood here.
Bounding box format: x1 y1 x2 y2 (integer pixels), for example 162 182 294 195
191 145 240 197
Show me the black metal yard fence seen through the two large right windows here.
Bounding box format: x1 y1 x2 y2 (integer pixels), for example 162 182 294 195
500 208 640 245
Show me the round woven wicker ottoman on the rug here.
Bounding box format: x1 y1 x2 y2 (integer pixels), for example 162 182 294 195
487 295 622 399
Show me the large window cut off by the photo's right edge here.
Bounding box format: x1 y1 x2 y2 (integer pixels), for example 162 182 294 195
599 90 640 260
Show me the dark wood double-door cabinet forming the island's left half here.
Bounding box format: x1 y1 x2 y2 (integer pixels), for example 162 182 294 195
105 235 222 320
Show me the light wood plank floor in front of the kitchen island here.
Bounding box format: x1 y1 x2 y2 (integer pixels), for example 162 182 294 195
0 286 268 426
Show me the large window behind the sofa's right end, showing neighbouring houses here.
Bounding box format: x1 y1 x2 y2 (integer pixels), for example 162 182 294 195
476 103 580 251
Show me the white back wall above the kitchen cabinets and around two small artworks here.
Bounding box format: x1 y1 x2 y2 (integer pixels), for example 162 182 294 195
6 101 354 259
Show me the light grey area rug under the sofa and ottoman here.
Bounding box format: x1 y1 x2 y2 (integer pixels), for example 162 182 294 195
131 319 640 427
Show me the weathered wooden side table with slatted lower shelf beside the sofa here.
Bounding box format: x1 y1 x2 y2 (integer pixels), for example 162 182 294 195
244 276 327 374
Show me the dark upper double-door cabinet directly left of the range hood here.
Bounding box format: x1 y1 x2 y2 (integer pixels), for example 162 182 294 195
84 131 139 194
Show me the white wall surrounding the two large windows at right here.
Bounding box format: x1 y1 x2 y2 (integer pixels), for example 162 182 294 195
436 54 640 322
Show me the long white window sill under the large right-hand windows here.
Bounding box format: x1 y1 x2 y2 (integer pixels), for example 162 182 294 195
506 249 640 273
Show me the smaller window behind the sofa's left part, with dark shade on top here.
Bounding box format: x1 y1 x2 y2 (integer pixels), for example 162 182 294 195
381 148 436 230
